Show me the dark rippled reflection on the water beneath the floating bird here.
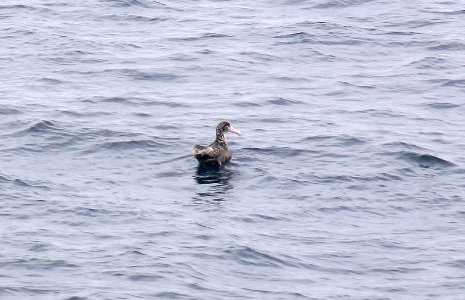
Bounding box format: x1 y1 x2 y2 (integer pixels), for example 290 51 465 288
194 164 233 202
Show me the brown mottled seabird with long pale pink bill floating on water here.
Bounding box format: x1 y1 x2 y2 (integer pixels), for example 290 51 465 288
192 121 241 165
